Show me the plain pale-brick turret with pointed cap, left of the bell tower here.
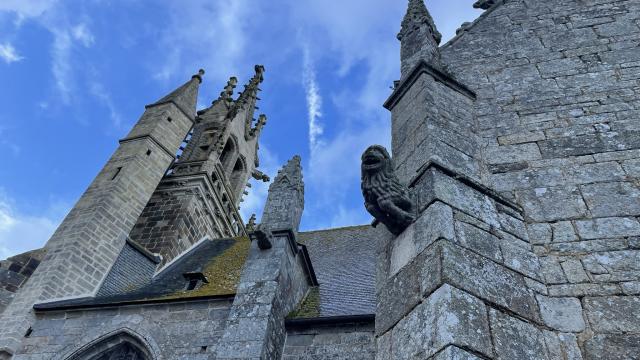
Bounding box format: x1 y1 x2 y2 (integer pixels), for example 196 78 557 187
0 71 204 359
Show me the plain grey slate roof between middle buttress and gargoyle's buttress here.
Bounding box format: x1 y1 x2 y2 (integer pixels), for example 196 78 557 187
293 225 377 317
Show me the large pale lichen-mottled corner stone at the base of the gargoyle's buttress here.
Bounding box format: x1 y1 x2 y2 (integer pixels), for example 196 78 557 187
392 285 493 360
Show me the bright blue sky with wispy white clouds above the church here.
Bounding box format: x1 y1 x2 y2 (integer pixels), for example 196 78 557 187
0 0 479 259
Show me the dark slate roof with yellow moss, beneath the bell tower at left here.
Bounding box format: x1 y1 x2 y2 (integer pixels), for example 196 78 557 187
34 237 250 311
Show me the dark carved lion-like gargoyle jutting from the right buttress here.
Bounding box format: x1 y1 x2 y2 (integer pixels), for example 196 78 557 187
361 145 415 235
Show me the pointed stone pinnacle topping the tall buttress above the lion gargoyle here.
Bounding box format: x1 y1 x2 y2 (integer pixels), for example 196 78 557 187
398 0 442 78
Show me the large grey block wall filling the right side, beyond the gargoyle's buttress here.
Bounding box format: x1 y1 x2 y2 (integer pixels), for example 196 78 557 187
442 0 640 359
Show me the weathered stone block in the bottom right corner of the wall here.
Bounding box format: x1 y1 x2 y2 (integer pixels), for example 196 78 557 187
585 334 640 360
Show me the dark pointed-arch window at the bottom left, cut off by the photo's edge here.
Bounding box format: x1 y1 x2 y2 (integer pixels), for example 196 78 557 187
66 331 153 360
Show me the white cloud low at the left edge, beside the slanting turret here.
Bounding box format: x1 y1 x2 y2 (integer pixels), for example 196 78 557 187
0 189 68 259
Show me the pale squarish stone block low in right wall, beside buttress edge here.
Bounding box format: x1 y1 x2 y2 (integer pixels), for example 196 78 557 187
536 295 585 332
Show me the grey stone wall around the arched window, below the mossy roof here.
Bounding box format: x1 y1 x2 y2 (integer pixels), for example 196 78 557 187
14 300 231 360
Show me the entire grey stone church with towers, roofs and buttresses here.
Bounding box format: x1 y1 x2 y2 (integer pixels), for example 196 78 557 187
0 0 640 360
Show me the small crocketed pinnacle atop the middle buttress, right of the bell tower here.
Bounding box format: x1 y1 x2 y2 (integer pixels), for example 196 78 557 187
261 155 304 232
